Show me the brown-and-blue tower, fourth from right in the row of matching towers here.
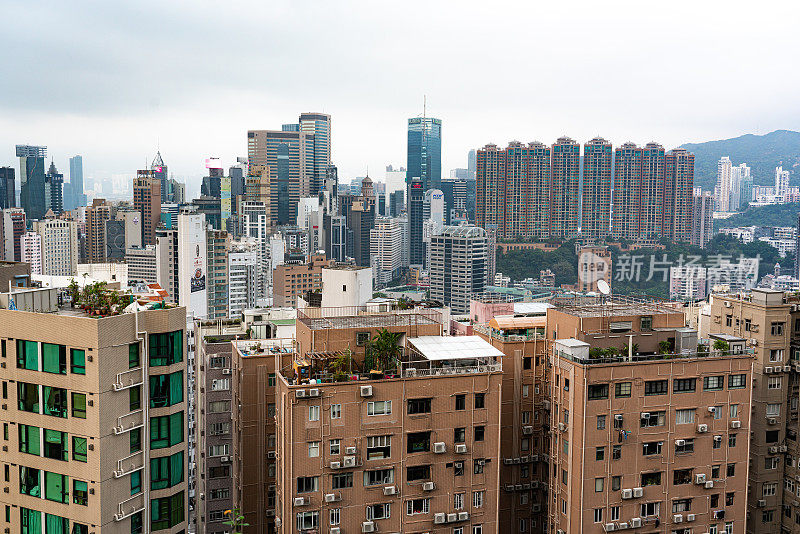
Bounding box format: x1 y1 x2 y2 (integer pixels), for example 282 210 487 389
581 137 613 239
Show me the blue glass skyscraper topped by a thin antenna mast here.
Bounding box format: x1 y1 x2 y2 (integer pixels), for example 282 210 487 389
406 117 442 191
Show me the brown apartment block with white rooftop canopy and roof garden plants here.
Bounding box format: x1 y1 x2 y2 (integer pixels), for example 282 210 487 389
275 336 502 534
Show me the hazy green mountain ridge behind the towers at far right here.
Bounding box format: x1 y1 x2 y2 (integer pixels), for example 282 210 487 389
681 130 800 191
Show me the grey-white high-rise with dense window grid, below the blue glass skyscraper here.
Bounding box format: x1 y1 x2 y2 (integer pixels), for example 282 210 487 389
430 226 488 313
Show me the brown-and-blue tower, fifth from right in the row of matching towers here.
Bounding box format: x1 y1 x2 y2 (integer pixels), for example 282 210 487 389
550 137 581 239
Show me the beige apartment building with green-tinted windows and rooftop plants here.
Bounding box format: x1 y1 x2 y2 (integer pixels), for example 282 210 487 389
0 289 189 534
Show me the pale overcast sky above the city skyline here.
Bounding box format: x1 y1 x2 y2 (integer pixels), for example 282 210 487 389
0 0 800 192
